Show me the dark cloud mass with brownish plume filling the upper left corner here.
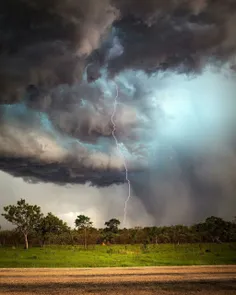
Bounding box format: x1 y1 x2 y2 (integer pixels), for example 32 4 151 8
0 0 117 103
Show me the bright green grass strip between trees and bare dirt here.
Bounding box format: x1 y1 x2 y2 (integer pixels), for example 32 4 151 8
0 244 236 267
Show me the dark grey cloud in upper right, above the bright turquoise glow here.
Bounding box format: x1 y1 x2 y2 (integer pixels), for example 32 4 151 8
109 0 236 74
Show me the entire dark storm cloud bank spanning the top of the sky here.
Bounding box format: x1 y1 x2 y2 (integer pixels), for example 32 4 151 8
0 0 236 103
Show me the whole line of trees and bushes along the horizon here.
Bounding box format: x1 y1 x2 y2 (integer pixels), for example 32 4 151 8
0 199 236 249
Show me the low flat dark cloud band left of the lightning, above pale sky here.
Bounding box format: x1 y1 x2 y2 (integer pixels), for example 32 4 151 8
0 157 125 187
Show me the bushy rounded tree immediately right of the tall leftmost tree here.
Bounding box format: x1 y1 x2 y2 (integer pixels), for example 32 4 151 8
35 212 69 246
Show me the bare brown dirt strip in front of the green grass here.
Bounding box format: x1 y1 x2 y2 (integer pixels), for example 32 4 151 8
0 266 236 295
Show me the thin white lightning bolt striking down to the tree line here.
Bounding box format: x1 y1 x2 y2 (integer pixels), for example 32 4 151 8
111 82 131 227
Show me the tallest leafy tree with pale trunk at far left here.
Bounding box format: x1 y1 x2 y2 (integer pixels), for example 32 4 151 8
2 199 43 249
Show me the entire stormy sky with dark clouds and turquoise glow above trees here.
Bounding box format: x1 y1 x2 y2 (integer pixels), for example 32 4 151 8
0 0 236 227
